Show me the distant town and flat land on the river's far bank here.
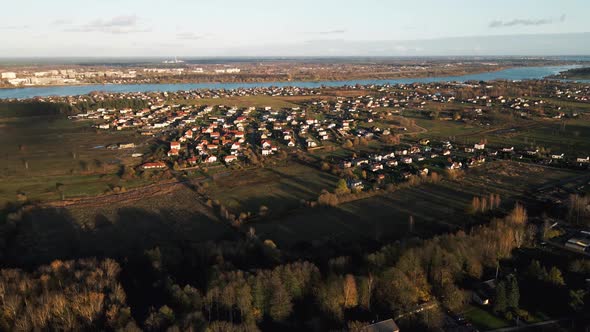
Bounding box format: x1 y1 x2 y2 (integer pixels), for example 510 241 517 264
0 58 571 88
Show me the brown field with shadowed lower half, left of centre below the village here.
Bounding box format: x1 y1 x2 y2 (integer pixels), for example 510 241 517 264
6 183 236 268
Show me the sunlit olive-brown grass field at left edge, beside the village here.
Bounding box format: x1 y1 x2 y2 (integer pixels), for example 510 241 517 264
0 116 144 206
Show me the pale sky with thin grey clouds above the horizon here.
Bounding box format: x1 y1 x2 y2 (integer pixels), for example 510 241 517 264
0 0 590 57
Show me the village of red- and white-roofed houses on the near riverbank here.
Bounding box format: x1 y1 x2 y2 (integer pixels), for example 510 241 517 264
60 84 590 189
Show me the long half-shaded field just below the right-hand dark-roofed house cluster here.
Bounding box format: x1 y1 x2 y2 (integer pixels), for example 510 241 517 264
254 162 579 246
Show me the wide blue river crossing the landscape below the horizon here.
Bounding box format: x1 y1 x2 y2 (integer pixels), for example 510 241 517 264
0 65 590 99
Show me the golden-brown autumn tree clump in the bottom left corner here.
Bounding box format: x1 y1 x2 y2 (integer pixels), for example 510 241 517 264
0 259 135 331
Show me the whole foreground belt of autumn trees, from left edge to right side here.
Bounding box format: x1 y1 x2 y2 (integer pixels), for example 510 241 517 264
0 205 532 331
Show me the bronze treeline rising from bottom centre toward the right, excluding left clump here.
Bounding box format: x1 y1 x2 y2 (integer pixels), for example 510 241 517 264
173 206 532 330
